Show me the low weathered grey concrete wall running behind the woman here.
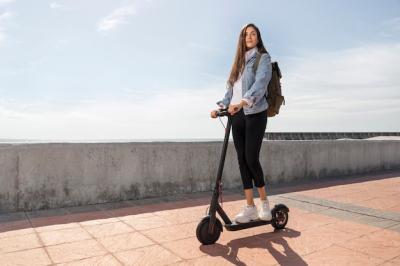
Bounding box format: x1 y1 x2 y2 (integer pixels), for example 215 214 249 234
0 140 400 211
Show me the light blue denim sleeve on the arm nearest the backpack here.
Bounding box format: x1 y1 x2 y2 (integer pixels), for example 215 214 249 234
243 53 272 107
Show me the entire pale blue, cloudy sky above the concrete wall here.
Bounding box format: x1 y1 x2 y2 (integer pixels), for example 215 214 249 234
0 0 400 140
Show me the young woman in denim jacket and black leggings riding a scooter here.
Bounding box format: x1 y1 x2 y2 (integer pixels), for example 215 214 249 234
211 24 272 223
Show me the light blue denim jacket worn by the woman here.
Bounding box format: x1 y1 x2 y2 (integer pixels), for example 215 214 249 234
217 51 272 115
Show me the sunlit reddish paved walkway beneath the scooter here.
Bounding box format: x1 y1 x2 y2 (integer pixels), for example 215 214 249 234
0 173 400 266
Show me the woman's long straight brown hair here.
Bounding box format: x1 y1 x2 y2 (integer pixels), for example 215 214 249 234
227 23 267 87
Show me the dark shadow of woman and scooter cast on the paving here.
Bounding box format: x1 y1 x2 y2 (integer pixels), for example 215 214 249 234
200 228 307 266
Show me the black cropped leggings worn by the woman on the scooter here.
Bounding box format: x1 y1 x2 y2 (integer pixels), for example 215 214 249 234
232 109 267 189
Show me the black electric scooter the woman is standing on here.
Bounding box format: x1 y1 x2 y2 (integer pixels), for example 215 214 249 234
196 108 289 245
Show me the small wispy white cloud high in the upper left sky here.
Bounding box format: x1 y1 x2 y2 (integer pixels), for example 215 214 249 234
97 5 136 31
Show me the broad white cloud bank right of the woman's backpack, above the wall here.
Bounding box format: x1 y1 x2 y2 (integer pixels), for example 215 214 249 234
271 43 400 131
